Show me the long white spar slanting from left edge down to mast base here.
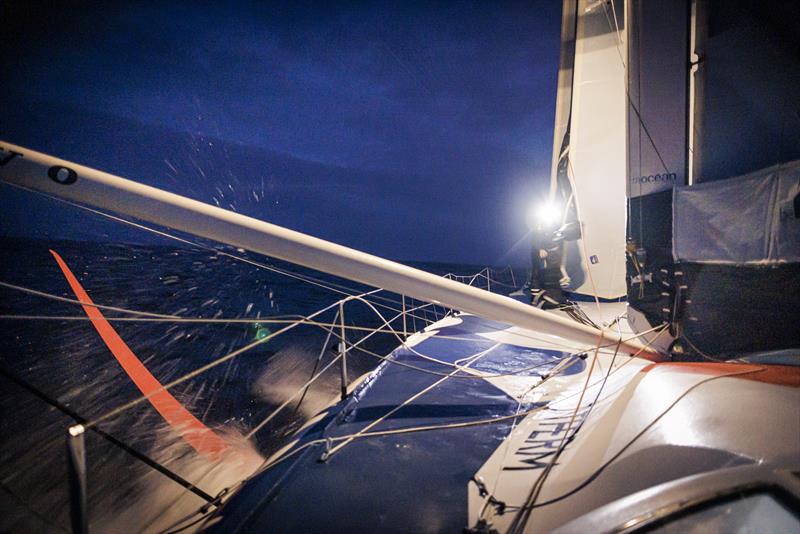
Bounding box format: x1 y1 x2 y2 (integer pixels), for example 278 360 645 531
0 141 660 358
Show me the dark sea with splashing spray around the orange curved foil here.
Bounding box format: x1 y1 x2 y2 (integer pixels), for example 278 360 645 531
0 238 520 532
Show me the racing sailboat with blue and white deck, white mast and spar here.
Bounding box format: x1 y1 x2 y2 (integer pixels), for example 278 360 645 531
0 0 800 532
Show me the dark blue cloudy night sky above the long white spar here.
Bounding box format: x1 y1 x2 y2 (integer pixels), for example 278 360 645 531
0 1 560 263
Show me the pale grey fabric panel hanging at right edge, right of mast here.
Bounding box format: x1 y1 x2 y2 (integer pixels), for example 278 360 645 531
672 160 800 264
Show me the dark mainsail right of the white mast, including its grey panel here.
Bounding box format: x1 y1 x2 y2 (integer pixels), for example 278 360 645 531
627 0 800 357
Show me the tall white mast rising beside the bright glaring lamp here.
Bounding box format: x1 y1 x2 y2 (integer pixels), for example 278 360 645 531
552 0 626 299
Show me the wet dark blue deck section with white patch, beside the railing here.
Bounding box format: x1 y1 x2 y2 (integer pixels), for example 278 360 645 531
211 303 644 532
